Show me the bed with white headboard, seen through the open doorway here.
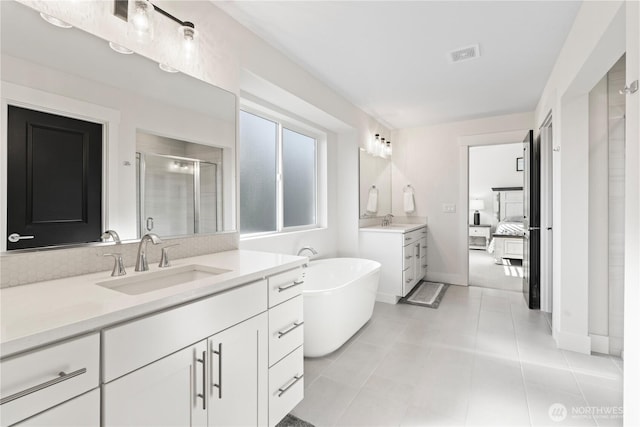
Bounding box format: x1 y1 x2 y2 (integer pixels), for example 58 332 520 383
487 187 524 264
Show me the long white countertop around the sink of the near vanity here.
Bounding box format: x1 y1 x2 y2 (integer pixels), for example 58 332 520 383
0 250 307 357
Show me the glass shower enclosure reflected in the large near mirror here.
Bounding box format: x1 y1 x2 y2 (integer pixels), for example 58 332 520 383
136 153 222 237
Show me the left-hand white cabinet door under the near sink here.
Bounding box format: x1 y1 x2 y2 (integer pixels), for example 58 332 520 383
103 341 207 426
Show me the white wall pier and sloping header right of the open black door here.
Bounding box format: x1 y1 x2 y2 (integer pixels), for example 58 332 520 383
536 1 625 353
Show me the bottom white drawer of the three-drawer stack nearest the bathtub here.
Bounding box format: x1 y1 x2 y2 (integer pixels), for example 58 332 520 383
269 347 304 426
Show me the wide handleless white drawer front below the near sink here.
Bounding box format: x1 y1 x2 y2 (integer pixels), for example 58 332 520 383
102 280 267 382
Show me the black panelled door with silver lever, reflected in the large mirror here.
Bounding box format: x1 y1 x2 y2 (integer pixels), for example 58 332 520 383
7 105 102 250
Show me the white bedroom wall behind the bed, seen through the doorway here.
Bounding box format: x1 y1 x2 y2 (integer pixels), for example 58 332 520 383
469 144 524 230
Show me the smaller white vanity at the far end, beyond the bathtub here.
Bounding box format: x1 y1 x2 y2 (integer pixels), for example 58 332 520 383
359 224 427 304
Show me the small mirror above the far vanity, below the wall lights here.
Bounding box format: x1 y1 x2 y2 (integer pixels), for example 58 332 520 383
360 150 391 218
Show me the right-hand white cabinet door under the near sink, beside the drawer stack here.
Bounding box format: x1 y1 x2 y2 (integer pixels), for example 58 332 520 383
208 313 268 426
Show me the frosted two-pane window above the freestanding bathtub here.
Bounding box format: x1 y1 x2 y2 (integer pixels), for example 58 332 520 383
239 111 318 234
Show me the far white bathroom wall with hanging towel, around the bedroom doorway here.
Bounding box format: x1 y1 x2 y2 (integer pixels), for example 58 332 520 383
391 113 533 285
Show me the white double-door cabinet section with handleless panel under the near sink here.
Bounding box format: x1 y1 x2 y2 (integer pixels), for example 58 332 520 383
103 280 268 426
